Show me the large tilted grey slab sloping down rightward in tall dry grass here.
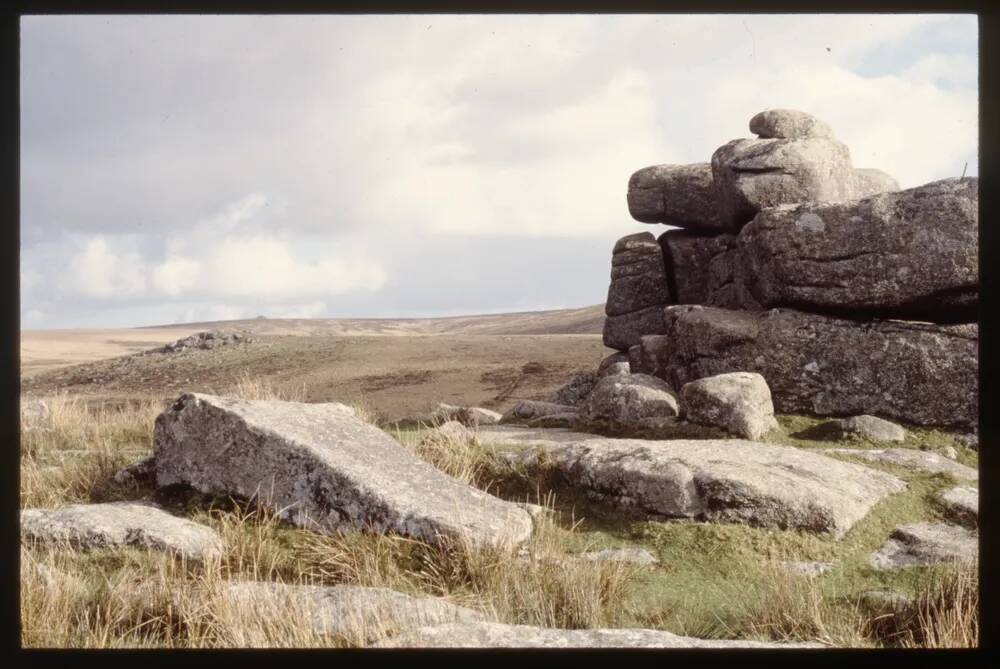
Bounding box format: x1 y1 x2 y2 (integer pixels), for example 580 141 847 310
153 393 531 546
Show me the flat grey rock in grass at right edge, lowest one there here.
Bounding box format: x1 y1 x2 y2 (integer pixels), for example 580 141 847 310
871 523 979 569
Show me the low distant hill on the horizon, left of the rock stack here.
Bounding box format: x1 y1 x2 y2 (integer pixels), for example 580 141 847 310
142 304 604 335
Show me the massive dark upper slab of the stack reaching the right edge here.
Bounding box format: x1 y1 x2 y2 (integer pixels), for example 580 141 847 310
728 178 979 322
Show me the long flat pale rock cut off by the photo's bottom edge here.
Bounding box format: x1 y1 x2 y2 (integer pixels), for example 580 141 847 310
375 622 822 648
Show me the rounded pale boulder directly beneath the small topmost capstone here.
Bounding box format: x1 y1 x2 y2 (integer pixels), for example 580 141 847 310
712 137 855 232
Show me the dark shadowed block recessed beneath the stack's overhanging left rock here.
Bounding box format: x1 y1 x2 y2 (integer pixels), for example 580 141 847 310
659 230 737 306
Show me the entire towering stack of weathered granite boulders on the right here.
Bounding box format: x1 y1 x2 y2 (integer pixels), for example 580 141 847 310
604 110 979 430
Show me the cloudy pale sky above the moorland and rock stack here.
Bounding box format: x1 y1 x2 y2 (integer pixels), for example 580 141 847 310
21 15 978 329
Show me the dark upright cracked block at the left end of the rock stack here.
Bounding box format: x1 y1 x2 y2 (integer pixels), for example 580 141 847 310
604 232 672 351
